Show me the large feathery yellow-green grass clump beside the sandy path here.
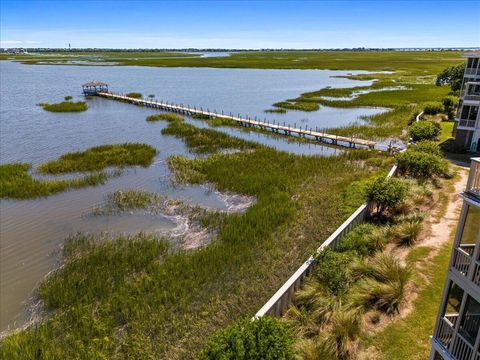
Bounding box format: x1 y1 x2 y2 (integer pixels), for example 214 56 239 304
351 253 411 314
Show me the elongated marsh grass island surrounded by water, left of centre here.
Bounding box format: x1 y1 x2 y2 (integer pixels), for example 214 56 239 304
37 143 157 174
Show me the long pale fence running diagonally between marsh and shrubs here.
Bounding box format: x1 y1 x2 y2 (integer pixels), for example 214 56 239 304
254 165 397 319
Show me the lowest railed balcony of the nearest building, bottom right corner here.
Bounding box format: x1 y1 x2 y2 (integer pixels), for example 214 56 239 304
434 314 480 360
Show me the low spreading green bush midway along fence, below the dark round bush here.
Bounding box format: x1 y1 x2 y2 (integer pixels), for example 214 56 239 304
336 224 385 257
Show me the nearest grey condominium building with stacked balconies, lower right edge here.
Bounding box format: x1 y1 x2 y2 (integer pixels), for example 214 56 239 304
430 158 480 360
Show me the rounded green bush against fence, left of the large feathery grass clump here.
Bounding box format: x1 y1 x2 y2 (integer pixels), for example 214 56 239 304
314 250 355 295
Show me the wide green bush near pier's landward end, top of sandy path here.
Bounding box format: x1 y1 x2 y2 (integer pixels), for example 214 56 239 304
396 150 449 178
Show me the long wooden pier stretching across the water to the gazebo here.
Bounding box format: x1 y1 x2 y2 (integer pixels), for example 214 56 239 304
96 92 388 152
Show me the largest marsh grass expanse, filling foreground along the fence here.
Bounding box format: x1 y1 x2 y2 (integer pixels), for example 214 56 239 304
0 123 390 359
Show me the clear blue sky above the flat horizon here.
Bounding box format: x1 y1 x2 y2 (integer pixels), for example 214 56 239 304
0 0 480 49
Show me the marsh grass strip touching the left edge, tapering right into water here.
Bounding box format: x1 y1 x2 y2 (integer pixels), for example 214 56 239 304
0 163 107 199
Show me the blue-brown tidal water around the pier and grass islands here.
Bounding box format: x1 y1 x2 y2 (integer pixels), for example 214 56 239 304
0 61 385 331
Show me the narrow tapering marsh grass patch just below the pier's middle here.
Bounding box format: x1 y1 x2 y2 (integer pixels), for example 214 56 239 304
162 122 259 154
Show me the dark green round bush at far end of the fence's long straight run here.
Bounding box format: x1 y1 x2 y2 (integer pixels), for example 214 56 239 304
366 176 407 215
